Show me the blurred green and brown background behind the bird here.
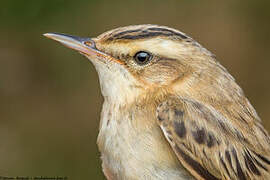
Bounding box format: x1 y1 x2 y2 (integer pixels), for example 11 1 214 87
0 0 270 179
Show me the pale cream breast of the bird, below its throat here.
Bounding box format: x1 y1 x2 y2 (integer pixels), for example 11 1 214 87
98 101 191 179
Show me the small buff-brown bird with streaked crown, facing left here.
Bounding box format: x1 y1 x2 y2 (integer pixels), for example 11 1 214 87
44 24 270 180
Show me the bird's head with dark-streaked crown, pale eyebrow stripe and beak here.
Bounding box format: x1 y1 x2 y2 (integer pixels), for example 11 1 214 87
44 25 217 103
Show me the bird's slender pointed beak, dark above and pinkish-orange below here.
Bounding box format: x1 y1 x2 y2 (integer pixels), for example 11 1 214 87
43 33 123 64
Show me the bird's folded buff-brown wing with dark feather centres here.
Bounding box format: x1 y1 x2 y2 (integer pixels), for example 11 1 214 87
156 98 270 180
